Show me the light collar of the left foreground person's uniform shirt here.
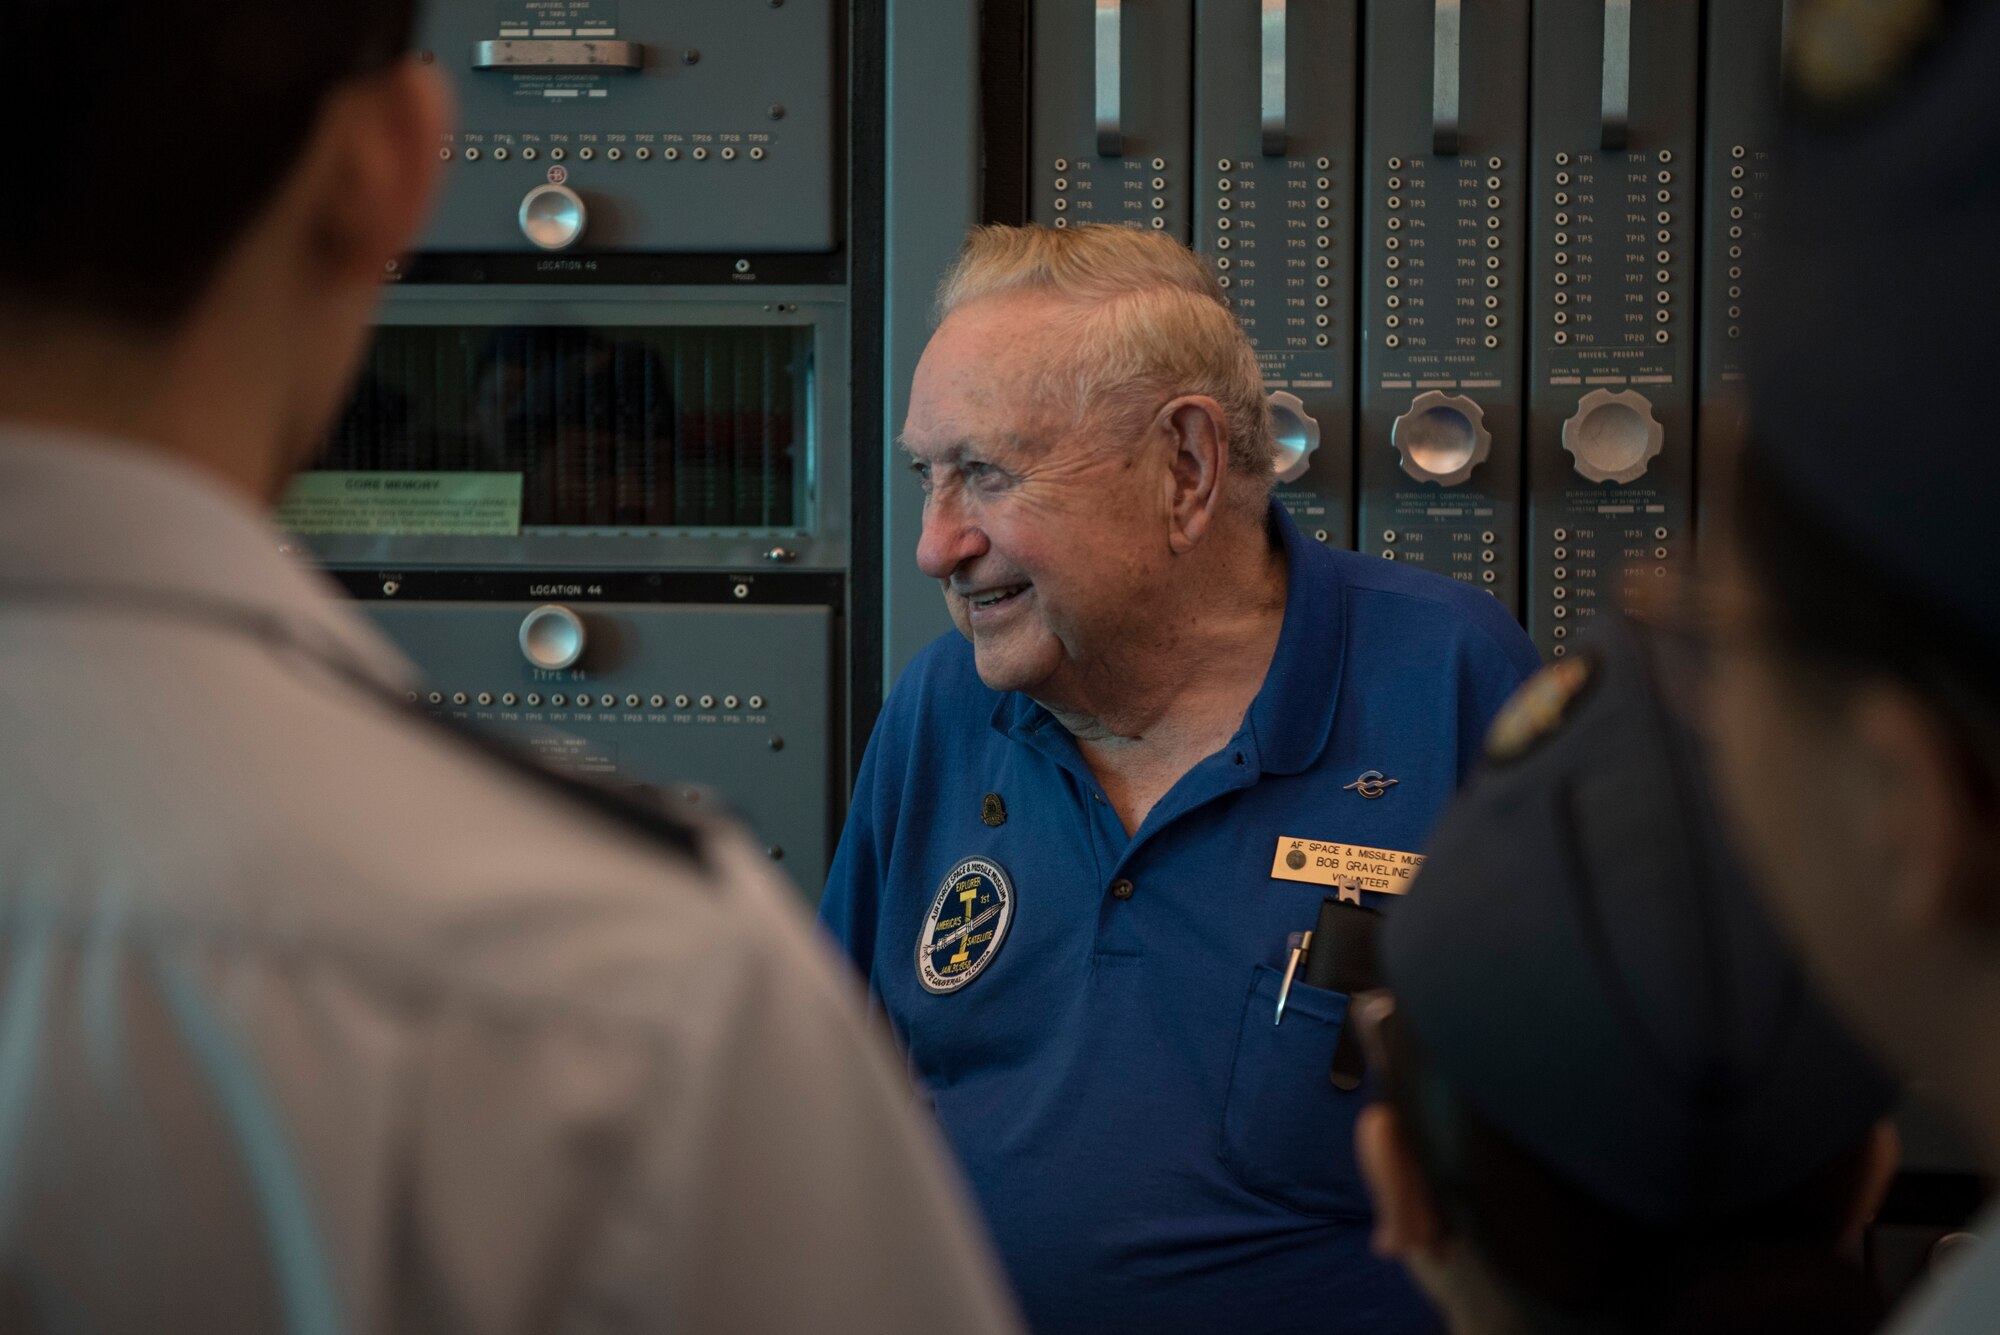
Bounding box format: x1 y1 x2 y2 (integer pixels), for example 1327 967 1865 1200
0 422 416 693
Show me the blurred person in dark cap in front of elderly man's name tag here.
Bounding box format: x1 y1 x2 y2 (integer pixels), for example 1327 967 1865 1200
1352 624 1896 1335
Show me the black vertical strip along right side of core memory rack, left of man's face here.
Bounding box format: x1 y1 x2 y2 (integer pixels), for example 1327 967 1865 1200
830 0 888 791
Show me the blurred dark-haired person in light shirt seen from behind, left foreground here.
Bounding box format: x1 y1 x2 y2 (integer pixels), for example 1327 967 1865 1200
0 0 1014 1335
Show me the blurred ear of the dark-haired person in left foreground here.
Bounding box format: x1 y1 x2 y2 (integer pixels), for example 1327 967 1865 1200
308 58 452 282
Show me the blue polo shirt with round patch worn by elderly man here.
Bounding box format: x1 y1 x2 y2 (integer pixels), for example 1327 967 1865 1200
820 504 1538 1335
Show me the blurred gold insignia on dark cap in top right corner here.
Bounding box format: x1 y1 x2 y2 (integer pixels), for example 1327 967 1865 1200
1786 0 1954 114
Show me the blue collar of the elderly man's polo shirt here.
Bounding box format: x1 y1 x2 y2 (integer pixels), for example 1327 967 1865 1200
992 500 1346 773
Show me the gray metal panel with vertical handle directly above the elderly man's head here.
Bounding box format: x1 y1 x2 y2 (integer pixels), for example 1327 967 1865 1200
1028 0 1194 242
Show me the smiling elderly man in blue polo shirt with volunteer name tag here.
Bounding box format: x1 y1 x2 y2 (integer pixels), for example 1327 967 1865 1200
822 228 1534 1335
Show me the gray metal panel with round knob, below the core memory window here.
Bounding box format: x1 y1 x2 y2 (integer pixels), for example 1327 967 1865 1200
366 602 834 901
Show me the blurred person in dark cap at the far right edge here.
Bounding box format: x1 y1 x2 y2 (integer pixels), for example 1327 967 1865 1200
1712 0 2000 1335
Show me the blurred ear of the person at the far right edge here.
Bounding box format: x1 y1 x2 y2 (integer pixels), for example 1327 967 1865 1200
1850 681 2000 937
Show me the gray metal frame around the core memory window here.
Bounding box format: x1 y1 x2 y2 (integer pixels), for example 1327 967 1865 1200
306 286 852 570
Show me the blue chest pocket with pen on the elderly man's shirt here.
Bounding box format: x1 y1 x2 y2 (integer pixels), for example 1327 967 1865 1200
1220 965 1372 1219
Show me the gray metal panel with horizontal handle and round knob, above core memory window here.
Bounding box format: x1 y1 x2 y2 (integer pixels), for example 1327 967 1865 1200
420 0 836 254
